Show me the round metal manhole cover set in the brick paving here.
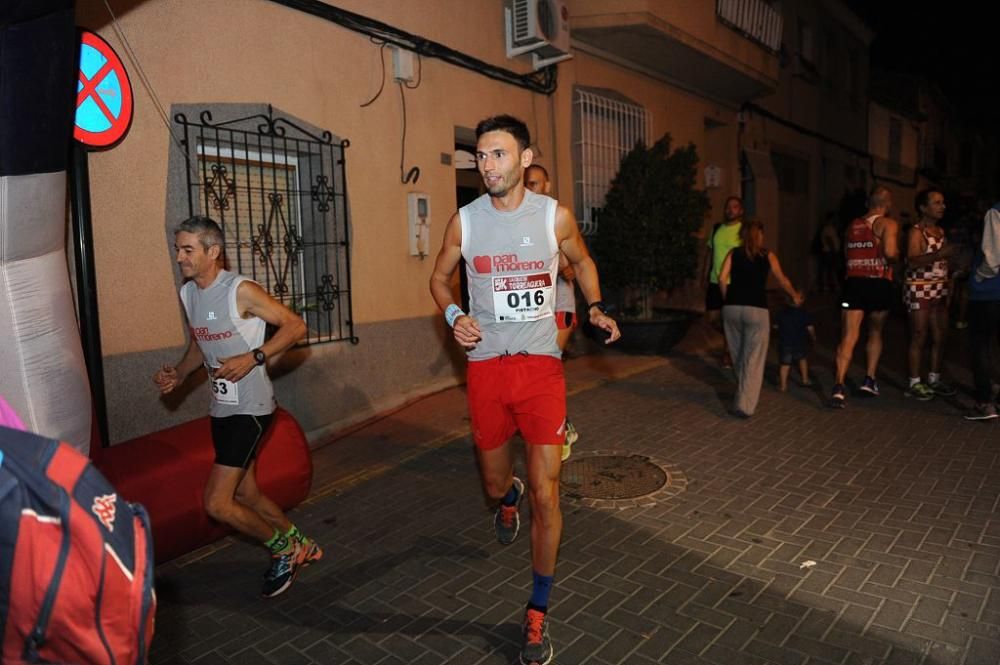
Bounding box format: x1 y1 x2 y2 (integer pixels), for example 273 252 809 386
562 455 669 499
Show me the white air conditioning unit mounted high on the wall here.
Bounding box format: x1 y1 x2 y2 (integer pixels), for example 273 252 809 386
504 0 573 70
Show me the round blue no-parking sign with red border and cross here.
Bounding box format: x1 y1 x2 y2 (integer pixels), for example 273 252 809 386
73 30 132 149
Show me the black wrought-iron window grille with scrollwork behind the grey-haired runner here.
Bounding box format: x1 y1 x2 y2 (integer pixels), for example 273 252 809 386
174 107 358 344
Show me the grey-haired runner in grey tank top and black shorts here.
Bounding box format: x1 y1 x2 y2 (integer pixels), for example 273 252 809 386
153 216 323 598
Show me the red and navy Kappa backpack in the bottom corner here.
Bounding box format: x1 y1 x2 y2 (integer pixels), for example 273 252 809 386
0 427 156 665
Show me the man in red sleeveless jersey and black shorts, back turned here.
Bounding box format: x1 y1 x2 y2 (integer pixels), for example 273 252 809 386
830 186 899 408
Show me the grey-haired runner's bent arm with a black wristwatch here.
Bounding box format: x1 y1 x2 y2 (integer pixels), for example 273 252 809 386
214 281 306 381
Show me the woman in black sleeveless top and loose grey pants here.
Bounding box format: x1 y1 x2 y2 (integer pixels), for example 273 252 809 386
719 220 802 418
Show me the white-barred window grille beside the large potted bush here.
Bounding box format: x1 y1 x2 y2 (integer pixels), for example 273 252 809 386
573 90 649 235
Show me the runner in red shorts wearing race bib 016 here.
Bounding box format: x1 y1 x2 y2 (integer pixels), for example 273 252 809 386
430 115 619 665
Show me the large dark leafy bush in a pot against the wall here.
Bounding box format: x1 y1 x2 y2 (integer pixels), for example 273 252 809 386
591 134 710 353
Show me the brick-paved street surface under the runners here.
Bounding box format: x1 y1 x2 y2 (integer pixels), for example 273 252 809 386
151 304 1000 665
